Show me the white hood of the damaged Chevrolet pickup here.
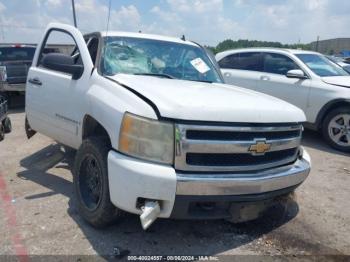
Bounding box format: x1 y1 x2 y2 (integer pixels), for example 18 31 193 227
110 74 306 123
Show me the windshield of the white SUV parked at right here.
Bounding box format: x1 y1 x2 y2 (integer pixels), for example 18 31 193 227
296 54 349 76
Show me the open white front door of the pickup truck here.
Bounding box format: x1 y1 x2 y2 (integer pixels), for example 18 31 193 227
26 25 93 148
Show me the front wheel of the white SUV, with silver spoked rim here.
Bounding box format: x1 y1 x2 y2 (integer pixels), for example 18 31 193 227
322 108 350 152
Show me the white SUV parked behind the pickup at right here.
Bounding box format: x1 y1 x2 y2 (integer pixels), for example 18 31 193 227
216 48 350 152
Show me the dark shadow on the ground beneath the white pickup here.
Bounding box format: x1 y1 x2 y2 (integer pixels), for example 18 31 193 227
17 144 299 260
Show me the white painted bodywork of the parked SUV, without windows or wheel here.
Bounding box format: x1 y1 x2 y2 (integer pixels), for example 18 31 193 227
216 48 350 123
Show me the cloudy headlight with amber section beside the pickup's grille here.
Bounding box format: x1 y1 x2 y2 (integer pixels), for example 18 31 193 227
119 113 174 164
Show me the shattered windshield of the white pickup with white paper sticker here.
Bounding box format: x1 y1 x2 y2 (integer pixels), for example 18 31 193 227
101 37 222 83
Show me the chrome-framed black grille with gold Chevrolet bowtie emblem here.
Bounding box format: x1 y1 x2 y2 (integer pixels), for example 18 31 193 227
175 124 302 172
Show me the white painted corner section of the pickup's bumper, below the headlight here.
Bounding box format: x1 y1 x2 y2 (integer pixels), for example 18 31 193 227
108 151 176 217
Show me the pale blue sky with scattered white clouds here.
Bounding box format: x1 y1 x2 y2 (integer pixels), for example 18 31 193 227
0 0 350 46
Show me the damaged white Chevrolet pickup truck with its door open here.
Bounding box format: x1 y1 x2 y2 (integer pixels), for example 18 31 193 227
26 24 310 229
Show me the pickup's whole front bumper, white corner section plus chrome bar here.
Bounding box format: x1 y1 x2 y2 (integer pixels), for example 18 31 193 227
108 148 311 218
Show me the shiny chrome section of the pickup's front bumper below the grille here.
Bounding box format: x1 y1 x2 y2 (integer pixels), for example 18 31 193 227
176 150 311 196
